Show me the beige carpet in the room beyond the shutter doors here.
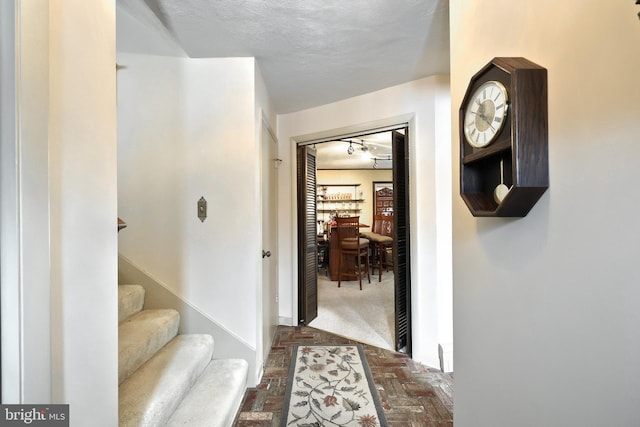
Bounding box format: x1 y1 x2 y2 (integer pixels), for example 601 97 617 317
309 271 395 350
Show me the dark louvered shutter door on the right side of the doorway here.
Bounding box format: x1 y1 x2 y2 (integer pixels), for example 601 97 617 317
392 128 411 355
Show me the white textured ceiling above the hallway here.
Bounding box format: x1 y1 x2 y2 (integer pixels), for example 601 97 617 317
132 0 449 114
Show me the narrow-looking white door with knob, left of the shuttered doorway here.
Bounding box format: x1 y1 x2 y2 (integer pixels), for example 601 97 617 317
262 122 279 362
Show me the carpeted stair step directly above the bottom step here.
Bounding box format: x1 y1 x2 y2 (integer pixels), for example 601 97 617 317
118 334 216 427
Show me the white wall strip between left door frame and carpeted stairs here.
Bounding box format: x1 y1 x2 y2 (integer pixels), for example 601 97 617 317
48 0 118 426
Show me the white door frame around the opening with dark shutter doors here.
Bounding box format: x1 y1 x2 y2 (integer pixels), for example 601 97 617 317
291 118 415 356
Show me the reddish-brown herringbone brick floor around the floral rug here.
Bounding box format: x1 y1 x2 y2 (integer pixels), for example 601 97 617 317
234 326 453 427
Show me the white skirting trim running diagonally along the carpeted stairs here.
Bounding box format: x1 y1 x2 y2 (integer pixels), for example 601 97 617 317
118 255 262 387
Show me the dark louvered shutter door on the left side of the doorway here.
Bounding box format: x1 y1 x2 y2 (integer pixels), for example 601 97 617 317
297 147 318 325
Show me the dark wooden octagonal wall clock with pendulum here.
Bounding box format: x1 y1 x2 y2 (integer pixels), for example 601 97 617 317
459 58 549 217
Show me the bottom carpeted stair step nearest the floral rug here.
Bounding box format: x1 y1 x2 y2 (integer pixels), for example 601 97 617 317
166 359 249 427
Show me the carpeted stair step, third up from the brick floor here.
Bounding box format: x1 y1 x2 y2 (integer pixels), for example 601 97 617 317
118 309 180 384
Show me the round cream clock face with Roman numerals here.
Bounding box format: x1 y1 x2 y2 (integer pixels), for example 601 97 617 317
464 80 509 148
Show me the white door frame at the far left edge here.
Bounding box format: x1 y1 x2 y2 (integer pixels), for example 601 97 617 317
0 0 56 403
